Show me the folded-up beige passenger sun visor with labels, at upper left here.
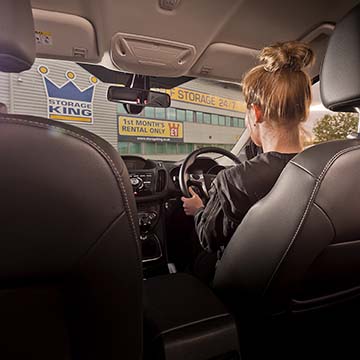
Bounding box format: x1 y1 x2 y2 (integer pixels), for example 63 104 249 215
33 9 100 62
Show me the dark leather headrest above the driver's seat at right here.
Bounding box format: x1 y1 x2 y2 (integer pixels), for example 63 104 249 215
320 5 360 112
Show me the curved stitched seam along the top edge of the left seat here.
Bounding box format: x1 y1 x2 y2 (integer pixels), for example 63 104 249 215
1 116 139 250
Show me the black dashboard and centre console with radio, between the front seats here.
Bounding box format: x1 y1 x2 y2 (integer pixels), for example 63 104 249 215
122 155 224 277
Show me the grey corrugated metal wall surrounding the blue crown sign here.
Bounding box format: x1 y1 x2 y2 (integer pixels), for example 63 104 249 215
10 59 118 149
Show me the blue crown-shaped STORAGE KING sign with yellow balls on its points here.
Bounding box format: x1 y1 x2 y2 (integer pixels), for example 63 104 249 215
38 65 98 124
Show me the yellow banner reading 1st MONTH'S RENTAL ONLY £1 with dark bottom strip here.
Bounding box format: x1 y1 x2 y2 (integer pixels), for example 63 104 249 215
118 115 184 142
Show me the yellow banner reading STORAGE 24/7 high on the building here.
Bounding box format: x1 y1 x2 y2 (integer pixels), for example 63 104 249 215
166 87 246 113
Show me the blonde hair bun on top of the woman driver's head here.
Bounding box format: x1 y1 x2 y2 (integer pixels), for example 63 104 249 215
259 41 314 72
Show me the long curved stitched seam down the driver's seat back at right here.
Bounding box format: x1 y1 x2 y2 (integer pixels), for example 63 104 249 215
262 145 360 296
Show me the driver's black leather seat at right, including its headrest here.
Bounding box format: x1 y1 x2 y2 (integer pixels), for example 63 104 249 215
214 6 360 359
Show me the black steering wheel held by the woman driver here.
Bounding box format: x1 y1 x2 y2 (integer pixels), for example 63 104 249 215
179 147 241 198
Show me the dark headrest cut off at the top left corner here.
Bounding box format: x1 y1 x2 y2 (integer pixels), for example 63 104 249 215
0 0 35 73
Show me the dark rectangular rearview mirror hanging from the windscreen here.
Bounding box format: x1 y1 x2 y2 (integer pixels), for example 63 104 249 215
107 86 171 108
